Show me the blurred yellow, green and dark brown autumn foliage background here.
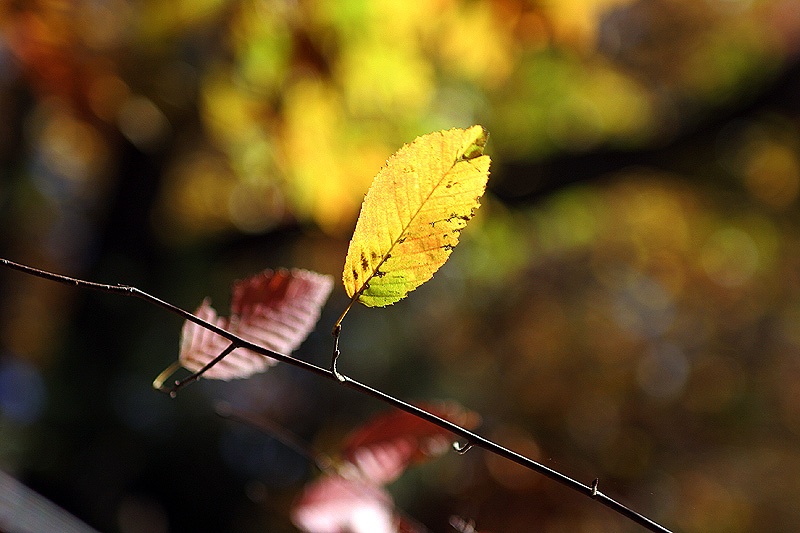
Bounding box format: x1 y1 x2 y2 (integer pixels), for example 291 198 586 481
0 0 800 532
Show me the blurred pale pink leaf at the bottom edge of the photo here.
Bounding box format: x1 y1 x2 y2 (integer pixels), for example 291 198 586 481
292 475 398 533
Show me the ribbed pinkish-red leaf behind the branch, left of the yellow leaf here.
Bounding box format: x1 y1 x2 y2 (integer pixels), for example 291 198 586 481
178 269 333 380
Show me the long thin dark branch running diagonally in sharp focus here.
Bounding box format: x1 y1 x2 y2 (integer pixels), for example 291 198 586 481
0 258 669 533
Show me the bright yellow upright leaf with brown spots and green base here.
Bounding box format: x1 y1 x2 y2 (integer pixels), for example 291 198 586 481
342 126 489 307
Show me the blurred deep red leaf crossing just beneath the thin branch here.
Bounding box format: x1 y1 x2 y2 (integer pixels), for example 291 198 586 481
342 402 480 485
